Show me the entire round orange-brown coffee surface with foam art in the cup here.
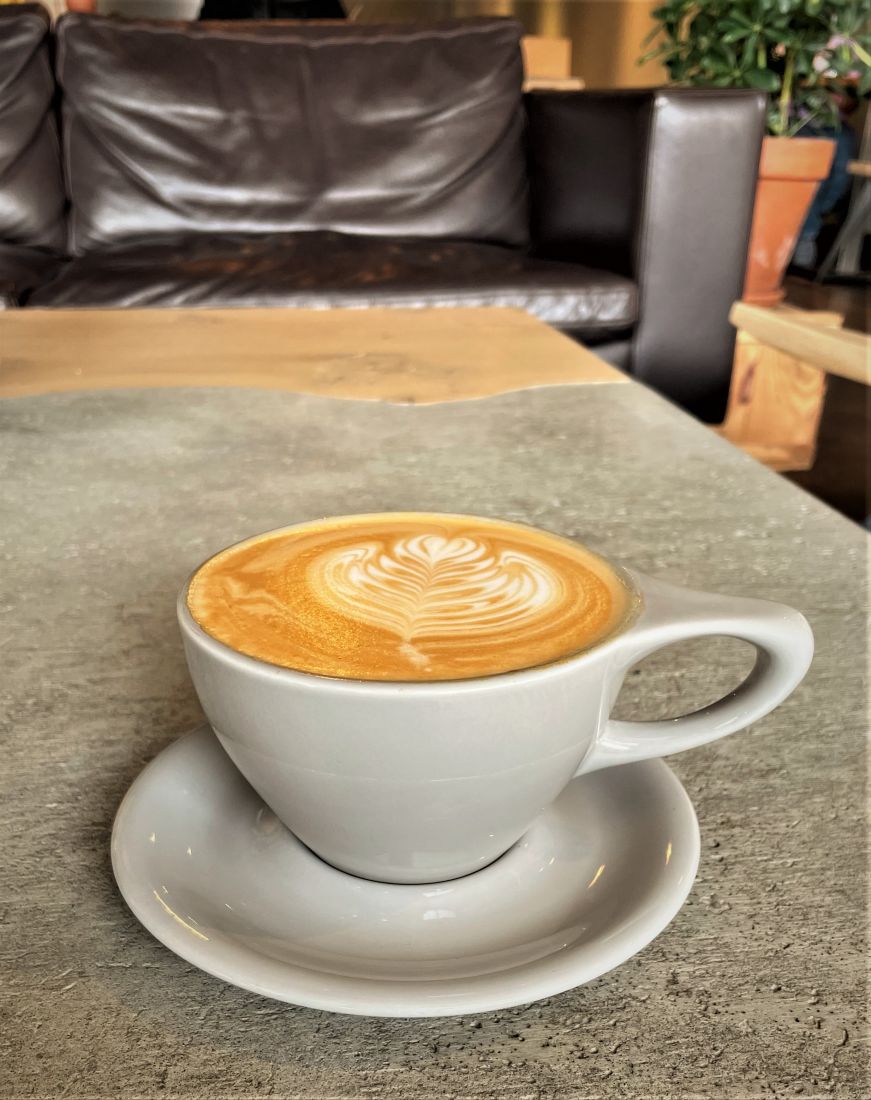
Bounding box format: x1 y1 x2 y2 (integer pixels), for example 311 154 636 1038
187 513 636 681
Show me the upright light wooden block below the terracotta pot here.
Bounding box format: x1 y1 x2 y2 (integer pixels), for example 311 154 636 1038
717 303 842 472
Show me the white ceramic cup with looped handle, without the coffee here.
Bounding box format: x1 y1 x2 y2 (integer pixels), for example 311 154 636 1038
178 523 814 882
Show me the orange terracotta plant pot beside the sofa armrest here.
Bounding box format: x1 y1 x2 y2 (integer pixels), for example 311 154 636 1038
743 138 835 306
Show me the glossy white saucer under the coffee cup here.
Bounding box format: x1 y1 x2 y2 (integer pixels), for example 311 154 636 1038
112 726 699 1016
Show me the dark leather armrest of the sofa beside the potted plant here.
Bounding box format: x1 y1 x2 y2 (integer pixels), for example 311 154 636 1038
526 88 765 421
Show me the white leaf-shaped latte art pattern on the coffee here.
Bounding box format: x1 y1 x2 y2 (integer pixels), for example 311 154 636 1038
309 535 562 668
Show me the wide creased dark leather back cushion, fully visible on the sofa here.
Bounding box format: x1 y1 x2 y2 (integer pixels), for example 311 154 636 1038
57 15 528 253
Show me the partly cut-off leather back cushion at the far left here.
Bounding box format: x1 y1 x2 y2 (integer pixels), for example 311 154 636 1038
0 4 66 251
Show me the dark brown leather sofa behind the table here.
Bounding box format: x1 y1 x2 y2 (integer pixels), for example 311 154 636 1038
0 4 764 420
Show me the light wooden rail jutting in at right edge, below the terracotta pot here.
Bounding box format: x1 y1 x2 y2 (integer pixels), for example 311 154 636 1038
729 301 871 385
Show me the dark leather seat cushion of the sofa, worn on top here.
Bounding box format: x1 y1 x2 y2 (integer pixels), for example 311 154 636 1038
31 232 637 339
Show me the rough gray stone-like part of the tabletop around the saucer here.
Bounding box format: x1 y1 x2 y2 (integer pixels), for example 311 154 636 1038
0 385 869 1100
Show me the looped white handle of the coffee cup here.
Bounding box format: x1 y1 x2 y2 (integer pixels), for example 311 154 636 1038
575 572 814 776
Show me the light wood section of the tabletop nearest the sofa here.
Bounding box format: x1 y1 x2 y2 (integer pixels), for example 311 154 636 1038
0 309 627 405
